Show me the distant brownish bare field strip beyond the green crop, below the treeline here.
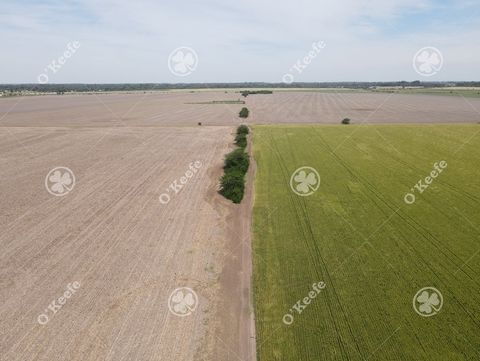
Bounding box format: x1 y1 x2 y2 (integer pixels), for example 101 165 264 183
0 89 480 128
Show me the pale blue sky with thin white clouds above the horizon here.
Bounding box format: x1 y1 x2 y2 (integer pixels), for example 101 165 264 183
0 0 480 83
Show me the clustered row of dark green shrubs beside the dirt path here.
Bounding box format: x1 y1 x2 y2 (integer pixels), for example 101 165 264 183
220 125 250 203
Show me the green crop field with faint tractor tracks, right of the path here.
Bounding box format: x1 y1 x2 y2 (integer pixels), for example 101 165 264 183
253 125 480 361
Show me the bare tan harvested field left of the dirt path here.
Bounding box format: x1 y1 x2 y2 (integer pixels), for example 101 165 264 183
0 122 255 361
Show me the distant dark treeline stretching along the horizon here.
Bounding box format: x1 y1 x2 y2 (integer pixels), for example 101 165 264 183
0 81 480 93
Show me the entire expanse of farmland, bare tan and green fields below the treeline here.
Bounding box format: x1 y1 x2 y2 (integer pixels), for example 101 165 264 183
0 89 480 361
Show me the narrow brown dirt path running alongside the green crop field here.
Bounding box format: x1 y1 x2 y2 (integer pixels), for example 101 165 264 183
215 129 256 361
